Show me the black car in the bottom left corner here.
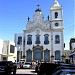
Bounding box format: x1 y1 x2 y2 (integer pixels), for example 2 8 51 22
0 61 16 75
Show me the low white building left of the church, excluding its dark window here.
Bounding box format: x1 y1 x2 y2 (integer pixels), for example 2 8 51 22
0 39 17 62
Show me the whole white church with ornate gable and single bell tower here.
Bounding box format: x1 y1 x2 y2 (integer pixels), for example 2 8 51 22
15 0 64 62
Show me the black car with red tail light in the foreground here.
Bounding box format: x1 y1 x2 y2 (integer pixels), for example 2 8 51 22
36 63 59 75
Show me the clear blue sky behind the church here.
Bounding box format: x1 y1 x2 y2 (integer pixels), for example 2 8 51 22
0 0 75 50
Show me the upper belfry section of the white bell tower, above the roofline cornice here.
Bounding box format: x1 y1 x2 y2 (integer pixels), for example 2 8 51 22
50 0 63 28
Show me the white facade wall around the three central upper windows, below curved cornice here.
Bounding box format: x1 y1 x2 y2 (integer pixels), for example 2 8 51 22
25 28 51 50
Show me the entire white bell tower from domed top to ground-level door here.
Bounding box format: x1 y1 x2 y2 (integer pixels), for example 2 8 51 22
50 0 64 60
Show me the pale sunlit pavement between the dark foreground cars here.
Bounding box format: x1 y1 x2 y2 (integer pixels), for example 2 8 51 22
16 69 37 75
